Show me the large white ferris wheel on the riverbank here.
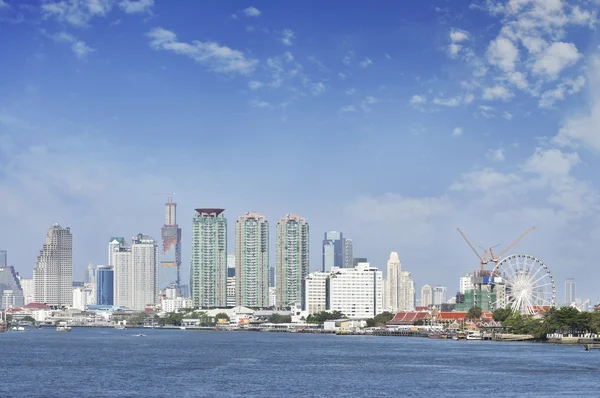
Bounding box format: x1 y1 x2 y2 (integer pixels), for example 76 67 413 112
487 254 556 315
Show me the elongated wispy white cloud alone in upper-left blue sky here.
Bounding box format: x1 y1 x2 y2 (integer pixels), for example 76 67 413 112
147 27 258 75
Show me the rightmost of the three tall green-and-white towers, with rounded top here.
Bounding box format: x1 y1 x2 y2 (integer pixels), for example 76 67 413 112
275 214 309 308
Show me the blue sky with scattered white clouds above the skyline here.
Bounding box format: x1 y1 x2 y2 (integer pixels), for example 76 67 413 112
0 0 600 302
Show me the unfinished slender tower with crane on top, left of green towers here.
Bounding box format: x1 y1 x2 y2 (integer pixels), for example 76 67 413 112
158 197 181 290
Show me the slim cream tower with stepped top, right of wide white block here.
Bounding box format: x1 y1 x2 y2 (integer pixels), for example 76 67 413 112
385 252 415 312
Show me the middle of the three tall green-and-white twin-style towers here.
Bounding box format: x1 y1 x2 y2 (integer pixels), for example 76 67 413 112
235 213 269 308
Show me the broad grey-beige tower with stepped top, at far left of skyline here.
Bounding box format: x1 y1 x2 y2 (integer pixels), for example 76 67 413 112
33 224 73 307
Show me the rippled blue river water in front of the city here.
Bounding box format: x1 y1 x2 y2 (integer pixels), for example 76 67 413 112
0 329 600 397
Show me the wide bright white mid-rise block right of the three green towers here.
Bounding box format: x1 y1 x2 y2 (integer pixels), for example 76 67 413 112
329 263 383 319
